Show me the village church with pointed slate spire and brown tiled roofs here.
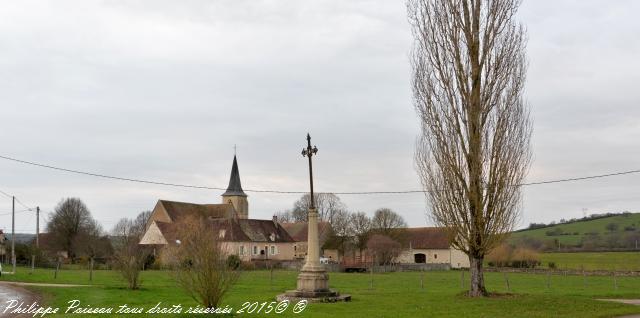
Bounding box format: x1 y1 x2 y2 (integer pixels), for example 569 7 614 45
140 156 296 261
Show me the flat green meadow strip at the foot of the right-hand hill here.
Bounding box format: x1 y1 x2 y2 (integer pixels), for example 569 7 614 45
540 252 640 271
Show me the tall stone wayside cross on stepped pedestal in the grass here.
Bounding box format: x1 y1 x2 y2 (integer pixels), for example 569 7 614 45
277 134 351 302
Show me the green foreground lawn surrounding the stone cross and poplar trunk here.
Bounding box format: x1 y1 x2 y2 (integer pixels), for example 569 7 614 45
2 268 640 318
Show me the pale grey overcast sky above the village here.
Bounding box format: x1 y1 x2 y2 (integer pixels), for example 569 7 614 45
0 0 640 232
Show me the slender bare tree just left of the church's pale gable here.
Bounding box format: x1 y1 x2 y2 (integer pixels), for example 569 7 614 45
112 212 151 289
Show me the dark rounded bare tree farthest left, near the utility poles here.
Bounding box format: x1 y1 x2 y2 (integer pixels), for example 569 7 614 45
47 198 100 260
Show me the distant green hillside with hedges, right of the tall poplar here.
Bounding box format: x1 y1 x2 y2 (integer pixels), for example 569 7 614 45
509 213 640 249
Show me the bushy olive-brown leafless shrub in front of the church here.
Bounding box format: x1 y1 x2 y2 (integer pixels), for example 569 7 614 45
167 217 240 308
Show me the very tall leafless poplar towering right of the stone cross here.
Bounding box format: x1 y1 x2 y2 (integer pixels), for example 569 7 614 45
407 0 531 297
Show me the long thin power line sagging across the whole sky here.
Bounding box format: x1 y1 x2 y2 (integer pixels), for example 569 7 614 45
0 155 640 195
